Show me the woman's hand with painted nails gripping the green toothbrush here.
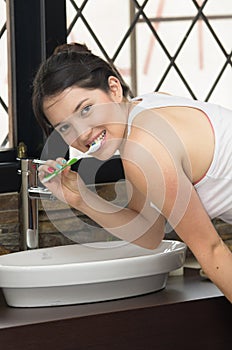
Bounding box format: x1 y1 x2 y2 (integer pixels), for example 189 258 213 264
38 158 87 209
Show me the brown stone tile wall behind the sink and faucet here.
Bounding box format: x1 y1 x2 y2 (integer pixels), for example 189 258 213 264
0 182 232 255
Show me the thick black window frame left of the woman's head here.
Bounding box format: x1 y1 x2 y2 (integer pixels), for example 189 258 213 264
0 0 66 193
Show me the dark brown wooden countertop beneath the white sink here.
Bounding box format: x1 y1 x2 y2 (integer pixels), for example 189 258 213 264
0 268 232 350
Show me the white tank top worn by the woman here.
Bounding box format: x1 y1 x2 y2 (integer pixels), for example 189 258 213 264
128 93 232 224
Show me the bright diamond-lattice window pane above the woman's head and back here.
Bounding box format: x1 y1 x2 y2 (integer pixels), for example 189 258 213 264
66 0 232 108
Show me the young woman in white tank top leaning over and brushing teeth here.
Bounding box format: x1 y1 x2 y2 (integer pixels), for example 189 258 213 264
33 44 232 301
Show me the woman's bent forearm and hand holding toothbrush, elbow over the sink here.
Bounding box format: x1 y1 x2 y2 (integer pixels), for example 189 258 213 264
40 161 165 249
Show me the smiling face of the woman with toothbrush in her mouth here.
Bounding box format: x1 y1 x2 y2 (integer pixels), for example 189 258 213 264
43 77 127 160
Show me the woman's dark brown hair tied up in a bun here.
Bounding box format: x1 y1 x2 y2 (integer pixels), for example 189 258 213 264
32 43 129 135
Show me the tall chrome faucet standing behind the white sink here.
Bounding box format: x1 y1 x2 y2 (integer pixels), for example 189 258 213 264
19 158 54 250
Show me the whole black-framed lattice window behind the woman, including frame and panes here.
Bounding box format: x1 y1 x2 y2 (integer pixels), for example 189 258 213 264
0 0 232 192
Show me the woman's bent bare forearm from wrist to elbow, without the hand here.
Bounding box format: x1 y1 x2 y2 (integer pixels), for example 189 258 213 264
78 179 165 249
